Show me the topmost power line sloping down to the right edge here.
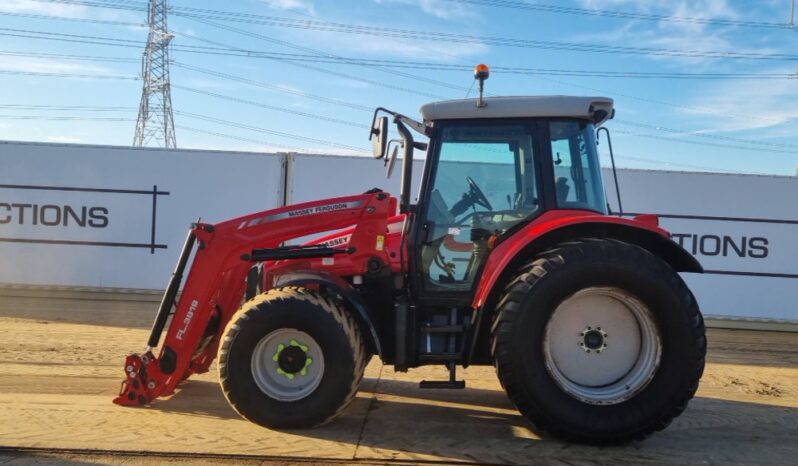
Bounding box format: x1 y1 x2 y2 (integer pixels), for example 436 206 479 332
449 0 793 29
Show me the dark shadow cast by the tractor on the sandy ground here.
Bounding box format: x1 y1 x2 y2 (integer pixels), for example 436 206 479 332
153 378 798 465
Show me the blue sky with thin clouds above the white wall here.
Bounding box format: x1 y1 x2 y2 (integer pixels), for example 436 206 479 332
0 0 798 175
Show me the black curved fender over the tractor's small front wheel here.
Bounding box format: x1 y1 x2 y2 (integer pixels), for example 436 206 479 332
272 271 383 358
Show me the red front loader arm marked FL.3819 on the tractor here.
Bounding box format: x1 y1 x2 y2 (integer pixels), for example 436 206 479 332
114 192 396 405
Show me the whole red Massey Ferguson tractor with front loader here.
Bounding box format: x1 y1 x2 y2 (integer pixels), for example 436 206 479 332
114 68 706 444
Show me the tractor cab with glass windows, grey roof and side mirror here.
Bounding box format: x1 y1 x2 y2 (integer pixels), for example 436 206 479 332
372 92 613 305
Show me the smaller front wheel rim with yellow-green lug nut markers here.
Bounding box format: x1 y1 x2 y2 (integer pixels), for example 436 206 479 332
251 329 324 401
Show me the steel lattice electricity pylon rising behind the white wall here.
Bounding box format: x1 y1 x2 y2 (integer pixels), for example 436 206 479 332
133 0 177 148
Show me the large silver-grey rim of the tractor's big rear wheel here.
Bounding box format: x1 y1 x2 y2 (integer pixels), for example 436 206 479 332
543 287 662 404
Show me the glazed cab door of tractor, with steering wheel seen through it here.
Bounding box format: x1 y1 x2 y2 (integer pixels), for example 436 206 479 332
411 119 543 306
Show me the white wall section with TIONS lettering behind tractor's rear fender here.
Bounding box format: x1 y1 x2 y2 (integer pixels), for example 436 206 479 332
604 170 798 320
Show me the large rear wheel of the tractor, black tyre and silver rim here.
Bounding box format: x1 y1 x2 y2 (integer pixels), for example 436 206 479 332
491 239 706 444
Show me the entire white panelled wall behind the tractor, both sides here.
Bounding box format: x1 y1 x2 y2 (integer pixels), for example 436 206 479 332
0 142 798 320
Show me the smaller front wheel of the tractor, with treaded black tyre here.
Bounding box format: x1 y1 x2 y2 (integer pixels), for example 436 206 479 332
219 287 367 428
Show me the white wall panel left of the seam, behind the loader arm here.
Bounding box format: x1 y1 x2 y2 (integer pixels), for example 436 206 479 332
0 143 282 289
